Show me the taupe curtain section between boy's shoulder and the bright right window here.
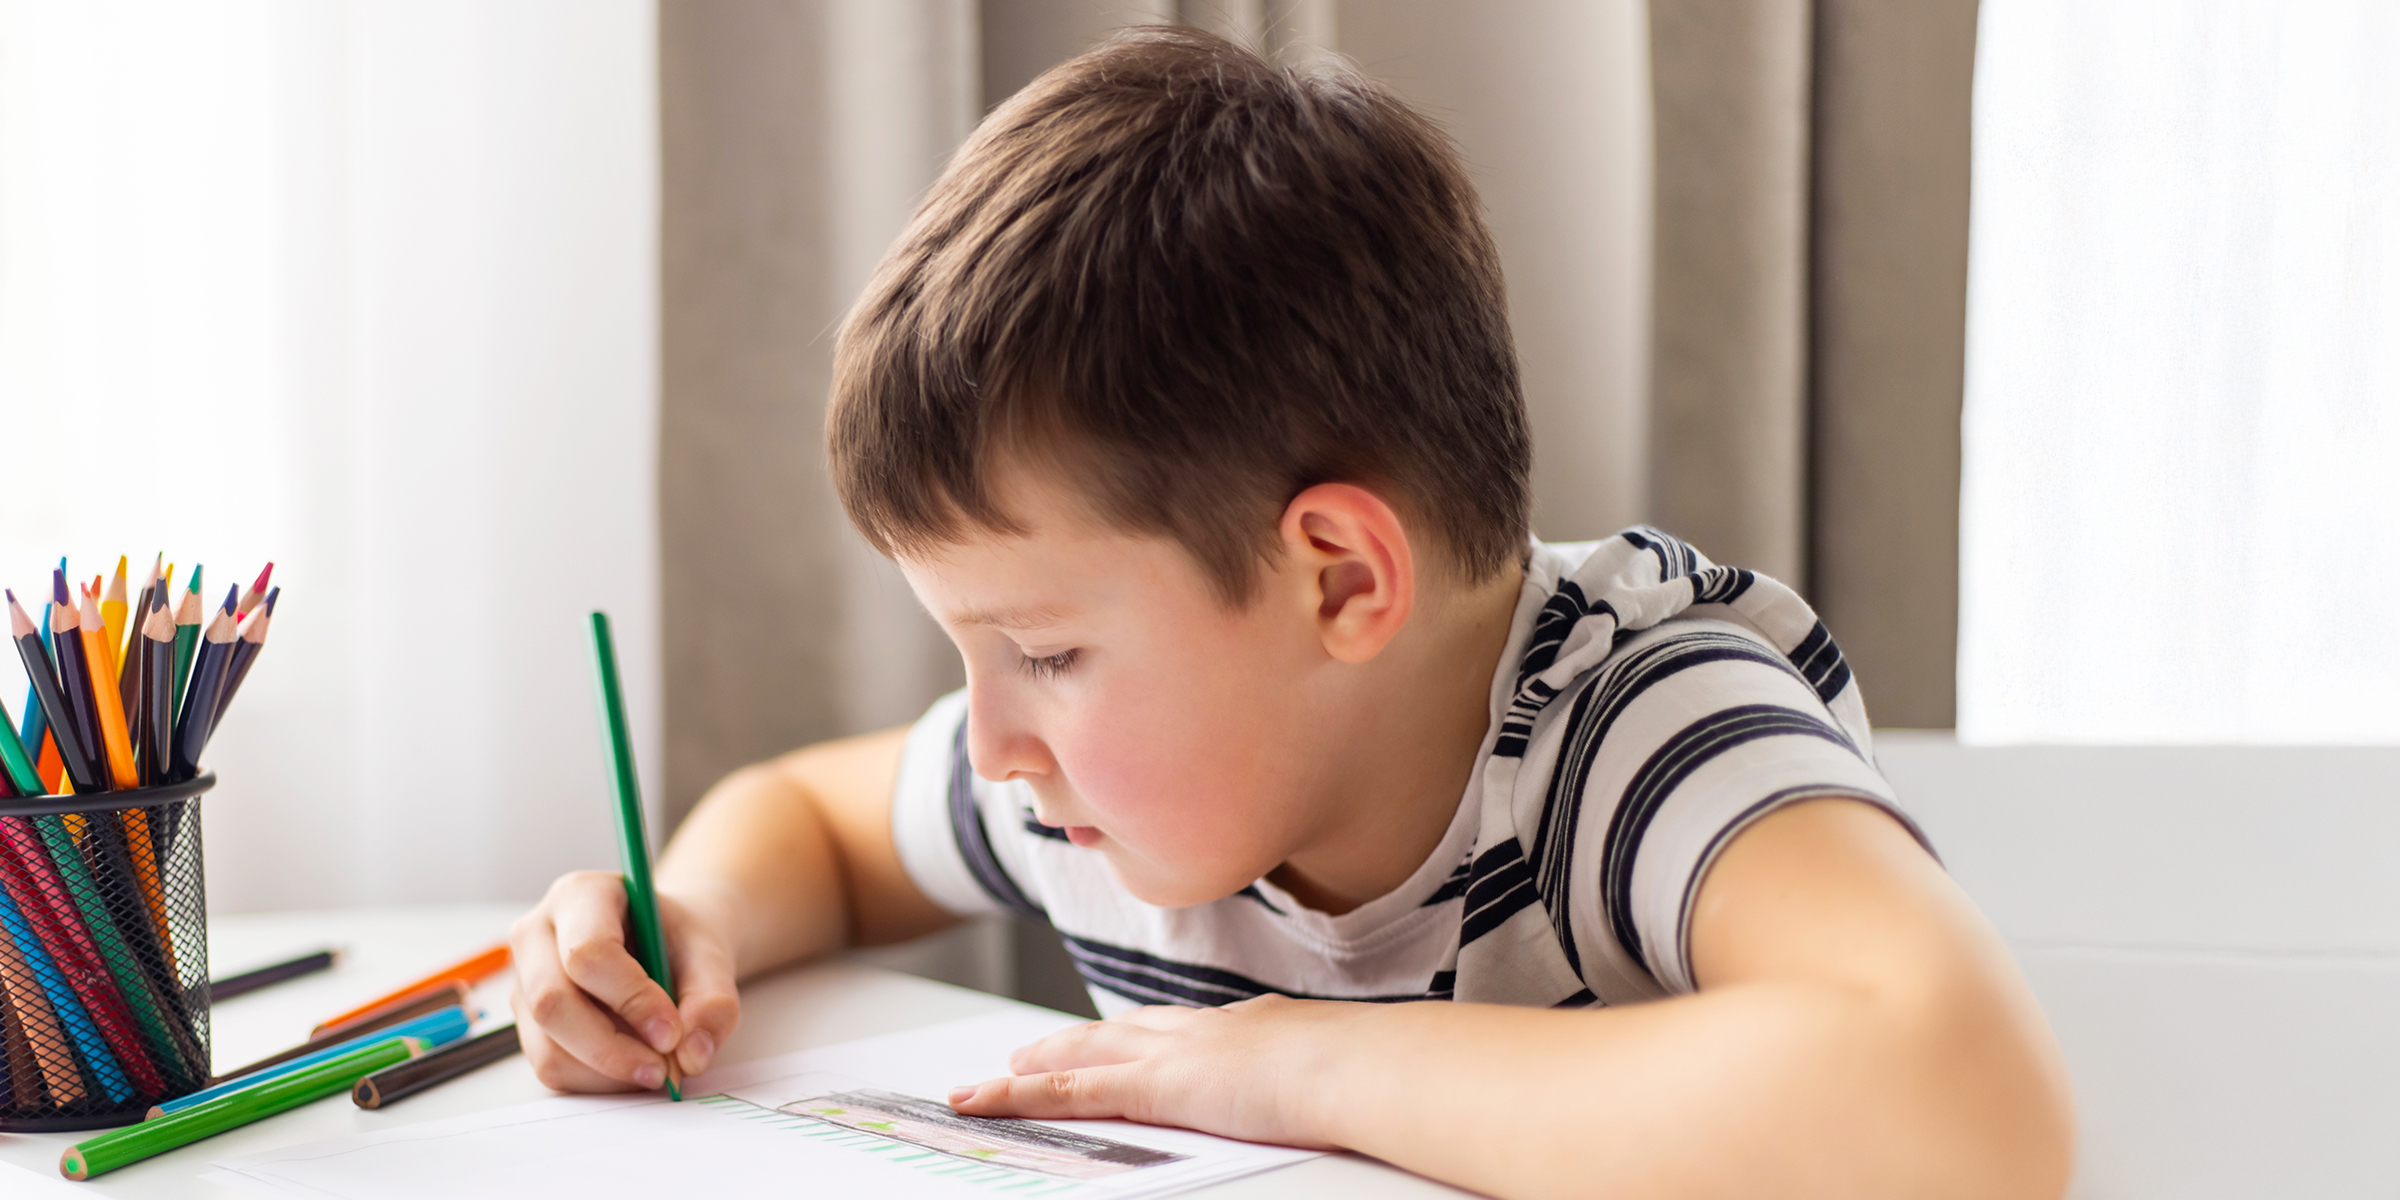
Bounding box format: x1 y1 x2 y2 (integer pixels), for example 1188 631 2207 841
1649 0 1975 727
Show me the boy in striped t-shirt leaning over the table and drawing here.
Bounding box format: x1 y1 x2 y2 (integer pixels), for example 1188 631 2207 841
514 31 2071 1198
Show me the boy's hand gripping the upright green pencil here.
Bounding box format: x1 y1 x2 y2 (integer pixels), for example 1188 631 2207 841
509 871 742 1092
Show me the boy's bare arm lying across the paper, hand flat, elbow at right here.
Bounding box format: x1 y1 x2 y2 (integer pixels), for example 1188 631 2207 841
953 802 2074 1200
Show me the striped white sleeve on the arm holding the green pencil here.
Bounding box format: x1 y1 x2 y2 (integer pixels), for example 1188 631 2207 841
893 689 1044 919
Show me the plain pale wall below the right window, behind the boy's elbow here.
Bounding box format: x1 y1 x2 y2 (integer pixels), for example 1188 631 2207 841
1877 732 2400 1200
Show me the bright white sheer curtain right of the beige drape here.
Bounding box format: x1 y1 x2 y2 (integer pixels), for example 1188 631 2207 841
1958 0 2400 742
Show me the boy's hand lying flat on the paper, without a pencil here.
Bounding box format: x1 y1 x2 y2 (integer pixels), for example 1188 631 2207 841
950 996 1382 1147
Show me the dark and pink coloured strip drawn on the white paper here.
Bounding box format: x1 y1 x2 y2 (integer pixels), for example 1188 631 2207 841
778 1087 1186 1178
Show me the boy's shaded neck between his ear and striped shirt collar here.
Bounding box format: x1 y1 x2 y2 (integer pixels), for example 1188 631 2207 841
1267 564 1524 914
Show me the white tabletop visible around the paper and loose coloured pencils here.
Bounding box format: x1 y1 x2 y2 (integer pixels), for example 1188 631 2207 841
0 905 1466 1200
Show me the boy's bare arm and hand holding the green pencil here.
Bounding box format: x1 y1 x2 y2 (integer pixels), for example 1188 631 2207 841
509 730 950 1092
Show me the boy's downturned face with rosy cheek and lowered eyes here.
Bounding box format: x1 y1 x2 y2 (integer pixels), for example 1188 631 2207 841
900 473 1342 905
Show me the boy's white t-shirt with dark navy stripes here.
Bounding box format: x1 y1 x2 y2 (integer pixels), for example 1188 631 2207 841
893 528 1913 1013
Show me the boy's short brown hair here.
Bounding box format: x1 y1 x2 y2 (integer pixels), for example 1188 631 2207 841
826 26 1531 605
